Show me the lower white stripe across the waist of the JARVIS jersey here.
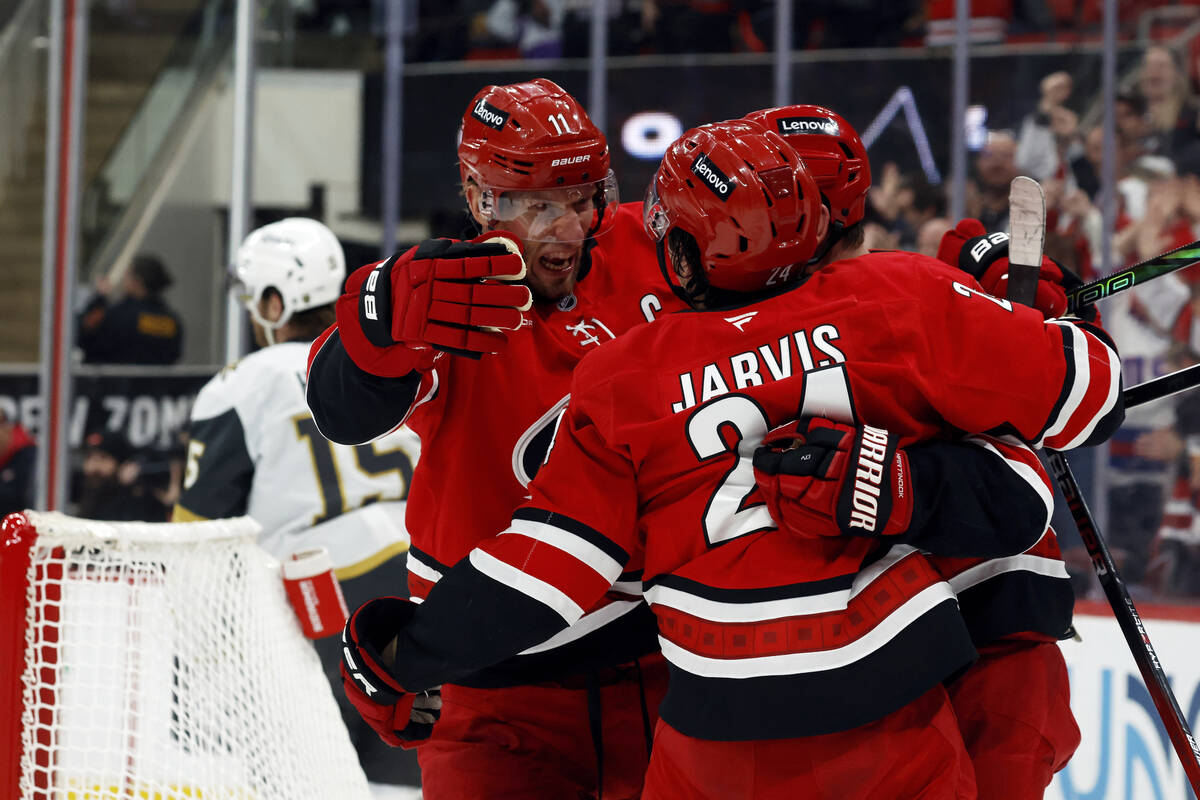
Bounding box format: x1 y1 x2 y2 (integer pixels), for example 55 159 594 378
659 582 954 678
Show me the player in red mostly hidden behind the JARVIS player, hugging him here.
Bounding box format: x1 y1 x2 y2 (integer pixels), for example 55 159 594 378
746 106 1079 800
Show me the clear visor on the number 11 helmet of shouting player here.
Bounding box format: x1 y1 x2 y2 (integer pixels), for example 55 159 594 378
480 170 619 242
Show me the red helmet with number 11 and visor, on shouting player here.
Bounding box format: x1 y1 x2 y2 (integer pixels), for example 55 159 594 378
458 78 619 240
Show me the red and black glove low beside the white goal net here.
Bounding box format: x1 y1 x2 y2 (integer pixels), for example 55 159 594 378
341 597 442 747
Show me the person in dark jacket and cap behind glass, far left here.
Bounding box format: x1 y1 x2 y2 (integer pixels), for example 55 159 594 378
79 255 184 363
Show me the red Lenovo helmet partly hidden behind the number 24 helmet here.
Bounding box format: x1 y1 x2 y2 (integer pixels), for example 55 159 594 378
745 106 871 229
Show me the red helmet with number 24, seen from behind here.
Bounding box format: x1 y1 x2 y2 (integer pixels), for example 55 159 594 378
643 120 821 298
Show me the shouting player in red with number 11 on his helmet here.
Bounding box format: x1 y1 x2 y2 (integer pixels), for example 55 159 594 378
308 79 682 800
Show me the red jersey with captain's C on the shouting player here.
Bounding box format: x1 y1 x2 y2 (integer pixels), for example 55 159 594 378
308 204 683 686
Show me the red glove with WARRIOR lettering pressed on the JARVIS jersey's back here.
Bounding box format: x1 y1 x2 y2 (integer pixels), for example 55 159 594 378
754 417 913 539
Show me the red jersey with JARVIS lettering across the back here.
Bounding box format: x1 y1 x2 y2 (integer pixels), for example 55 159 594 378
395 253 1122 740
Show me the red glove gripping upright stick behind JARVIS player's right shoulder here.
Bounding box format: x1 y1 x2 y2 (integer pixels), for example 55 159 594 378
937 218 1096 321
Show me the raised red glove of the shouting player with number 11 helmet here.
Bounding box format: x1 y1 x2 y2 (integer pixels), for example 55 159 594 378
358 234 533 359
